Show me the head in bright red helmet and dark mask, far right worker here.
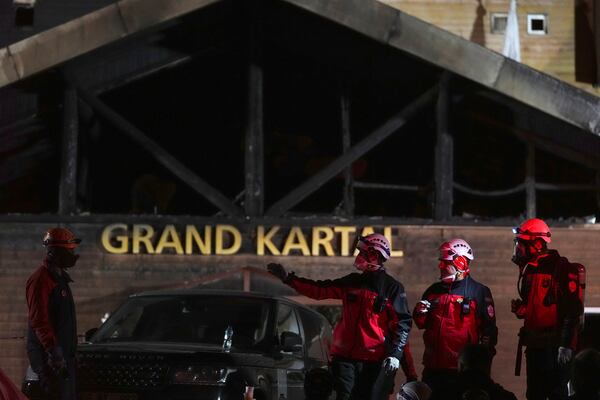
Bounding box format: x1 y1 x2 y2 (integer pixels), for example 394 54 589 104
512 218 552 267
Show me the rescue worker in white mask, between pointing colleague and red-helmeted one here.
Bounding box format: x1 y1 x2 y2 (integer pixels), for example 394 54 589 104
413 239 498 400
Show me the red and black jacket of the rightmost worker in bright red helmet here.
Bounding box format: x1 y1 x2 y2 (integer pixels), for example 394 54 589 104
517 250 583 349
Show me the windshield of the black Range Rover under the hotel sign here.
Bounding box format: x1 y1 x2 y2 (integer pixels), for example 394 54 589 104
91 296 271 349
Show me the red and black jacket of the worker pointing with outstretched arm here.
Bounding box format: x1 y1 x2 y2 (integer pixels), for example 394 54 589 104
286 269 412 361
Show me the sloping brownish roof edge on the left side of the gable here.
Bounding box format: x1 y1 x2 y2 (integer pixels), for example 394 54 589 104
0 0 220 88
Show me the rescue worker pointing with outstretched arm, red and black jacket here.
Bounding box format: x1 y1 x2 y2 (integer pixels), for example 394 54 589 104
268 233 416 400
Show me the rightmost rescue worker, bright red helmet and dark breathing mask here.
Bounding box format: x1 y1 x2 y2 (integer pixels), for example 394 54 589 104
511 218 583 400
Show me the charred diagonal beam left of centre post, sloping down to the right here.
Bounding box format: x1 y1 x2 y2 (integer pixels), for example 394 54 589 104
79 89 242 216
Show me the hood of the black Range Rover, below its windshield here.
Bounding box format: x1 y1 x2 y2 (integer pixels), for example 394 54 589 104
77 342 274 366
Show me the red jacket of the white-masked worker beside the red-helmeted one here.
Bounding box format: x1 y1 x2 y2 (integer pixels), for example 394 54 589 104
413 276 498 370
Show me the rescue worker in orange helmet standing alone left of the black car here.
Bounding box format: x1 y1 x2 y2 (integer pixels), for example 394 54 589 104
26 228 81 400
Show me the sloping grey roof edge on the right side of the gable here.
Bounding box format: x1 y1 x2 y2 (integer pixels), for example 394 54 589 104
282 0 600 136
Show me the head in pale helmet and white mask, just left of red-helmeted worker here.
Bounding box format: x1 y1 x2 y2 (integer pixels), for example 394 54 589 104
438 239 475 283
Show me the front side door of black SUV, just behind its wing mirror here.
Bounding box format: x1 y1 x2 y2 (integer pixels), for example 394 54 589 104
275 302 304 400
